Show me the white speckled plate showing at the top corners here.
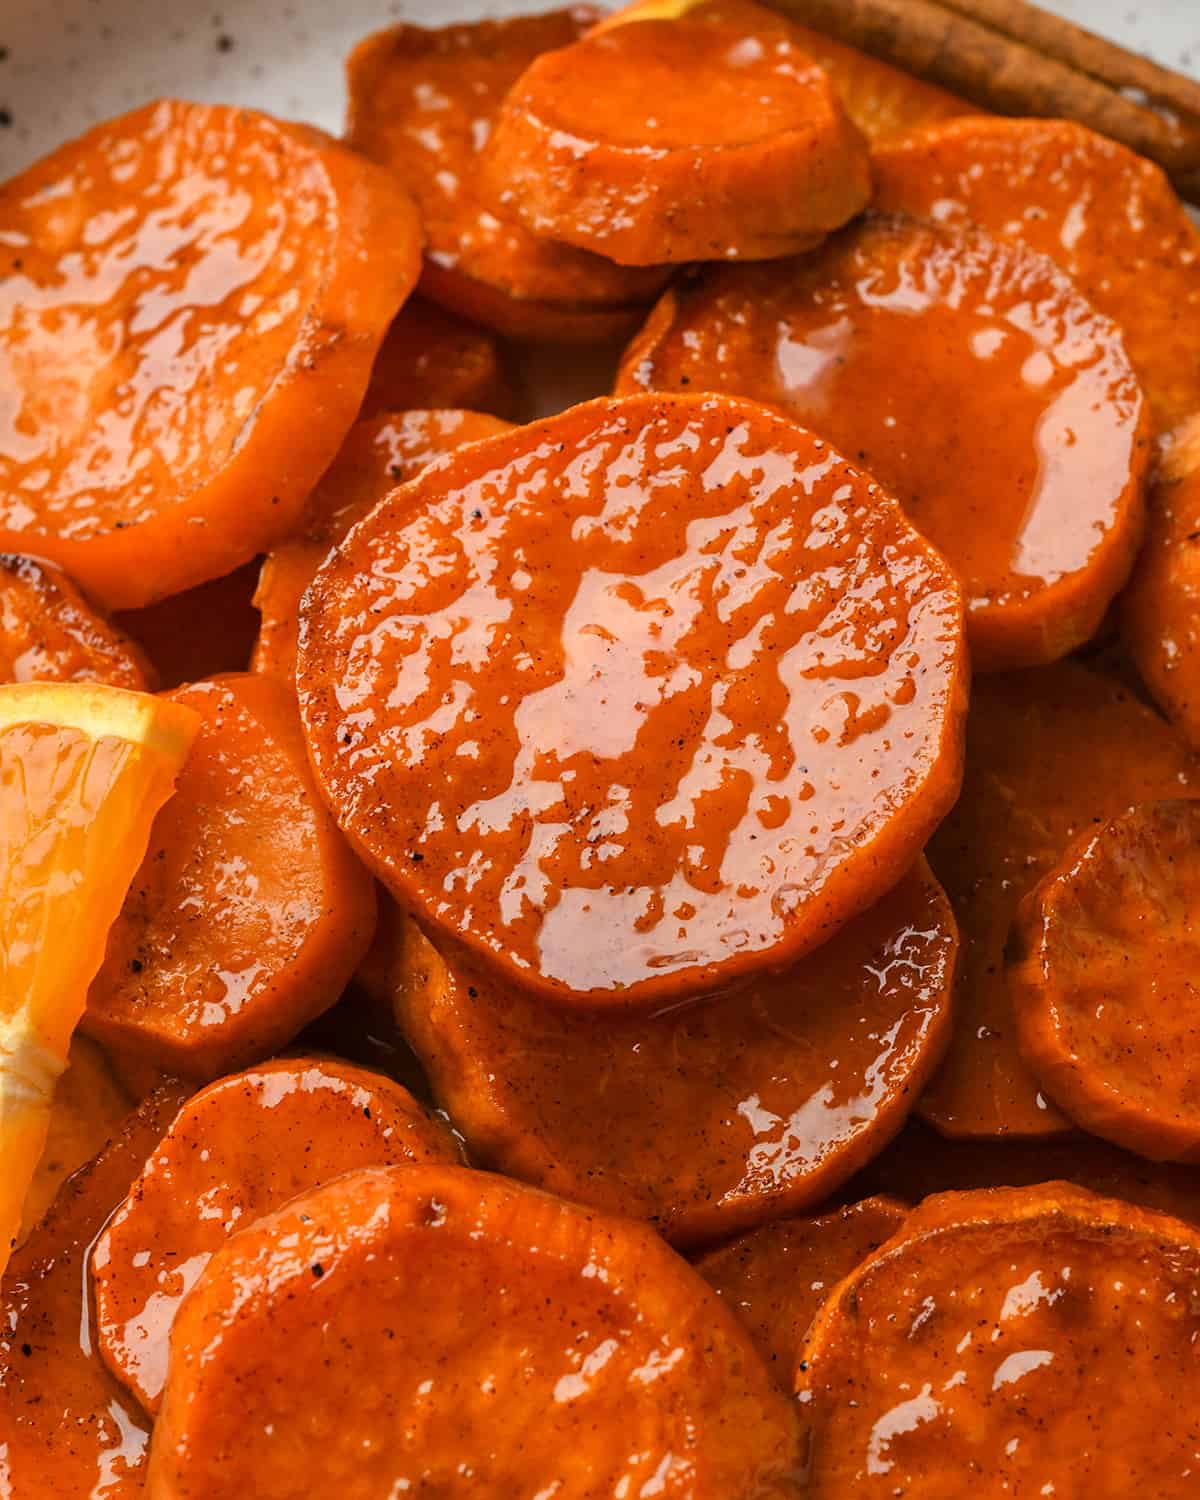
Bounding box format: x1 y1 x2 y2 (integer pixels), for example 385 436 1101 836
0 0 1200 177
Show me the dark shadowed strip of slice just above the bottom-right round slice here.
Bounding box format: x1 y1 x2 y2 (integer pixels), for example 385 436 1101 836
846 1118 1200 1223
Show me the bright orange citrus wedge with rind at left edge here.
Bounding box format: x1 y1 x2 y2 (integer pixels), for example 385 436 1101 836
0 683 200 1271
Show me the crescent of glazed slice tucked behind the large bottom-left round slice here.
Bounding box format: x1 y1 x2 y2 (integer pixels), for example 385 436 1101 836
92 1058 462 1412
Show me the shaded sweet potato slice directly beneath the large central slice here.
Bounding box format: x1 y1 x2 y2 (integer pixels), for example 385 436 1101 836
393 863 957 1245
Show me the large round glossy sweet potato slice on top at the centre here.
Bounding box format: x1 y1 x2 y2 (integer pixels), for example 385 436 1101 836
297 396 965 1007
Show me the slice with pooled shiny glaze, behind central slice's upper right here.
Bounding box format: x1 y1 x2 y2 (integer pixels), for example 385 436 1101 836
617 216 1149 671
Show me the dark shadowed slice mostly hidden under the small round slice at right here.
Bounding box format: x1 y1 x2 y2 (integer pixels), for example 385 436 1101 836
920 662 1200 1136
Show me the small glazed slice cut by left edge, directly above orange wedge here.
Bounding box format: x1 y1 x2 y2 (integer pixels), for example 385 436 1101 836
0 552 155 692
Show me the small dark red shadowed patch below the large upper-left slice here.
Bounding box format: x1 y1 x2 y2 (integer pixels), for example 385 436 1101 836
116 558 261 689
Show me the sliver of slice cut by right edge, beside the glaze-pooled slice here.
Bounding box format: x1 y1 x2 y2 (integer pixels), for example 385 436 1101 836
1121 422 1200 750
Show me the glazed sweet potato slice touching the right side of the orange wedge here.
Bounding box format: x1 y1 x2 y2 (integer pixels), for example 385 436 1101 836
84 675 375 1079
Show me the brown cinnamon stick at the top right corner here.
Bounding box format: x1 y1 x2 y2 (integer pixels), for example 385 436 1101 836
773 0 1200 201
